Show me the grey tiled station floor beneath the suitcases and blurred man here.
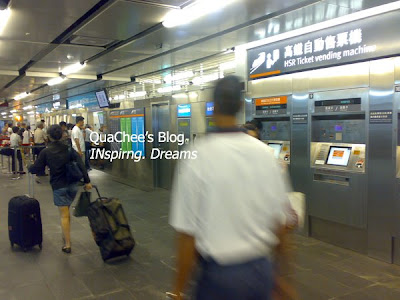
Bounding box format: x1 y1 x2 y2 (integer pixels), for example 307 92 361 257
0 170 400 300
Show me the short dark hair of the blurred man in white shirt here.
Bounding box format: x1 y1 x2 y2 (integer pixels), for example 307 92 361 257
214 76 242 116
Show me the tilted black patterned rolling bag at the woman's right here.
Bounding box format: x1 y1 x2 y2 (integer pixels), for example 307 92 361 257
88 187 135 261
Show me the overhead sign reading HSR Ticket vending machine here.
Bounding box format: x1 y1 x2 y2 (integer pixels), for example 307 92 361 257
248 11 400 80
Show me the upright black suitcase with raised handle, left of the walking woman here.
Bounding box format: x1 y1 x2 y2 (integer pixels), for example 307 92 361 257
8 174 43 251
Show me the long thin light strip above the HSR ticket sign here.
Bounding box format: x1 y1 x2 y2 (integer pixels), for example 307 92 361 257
235 1 400 50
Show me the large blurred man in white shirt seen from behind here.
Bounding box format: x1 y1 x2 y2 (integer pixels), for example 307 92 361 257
170 76 289 300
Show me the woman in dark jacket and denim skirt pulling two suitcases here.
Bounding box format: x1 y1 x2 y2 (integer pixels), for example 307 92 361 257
29 125 92 253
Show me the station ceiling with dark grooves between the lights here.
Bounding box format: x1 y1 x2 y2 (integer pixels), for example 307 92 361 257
0 0 395 110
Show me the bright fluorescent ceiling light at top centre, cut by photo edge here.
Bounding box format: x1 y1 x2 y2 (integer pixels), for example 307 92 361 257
163 0 235 28
